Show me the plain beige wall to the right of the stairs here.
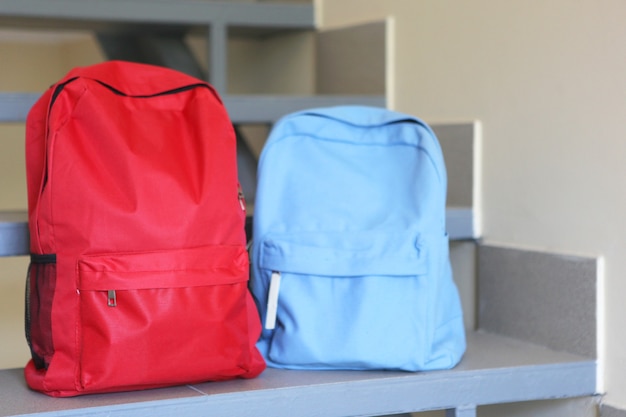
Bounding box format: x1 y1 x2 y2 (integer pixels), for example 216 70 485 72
316 0 626 408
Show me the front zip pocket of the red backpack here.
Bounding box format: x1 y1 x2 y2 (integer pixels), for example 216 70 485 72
78 246 250 391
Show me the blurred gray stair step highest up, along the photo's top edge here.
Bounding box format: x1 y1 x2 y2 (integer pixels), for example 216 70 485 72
0 0 315 31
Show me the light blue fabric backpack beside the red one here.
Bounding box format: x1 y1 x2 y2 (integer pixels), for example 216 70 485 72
251 106 465 371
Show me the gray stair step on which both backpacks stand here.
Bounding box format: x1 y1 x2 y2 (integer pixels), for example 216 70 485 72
0 333 596 417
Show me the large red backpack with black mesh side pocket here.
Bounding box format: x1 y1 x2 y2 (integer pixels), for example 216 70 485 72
25 61 265 397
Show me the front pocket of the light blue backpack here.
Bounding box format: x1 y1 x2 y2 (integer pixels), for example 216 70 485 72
258 231 432 371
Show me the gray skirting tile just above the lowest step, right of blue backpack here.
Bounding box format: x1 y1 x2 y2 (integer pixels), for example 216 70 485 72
478 245 597 358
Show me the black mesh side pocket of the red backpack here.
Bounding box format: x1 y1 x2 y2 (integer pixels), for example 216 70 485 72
25 254 57 369
